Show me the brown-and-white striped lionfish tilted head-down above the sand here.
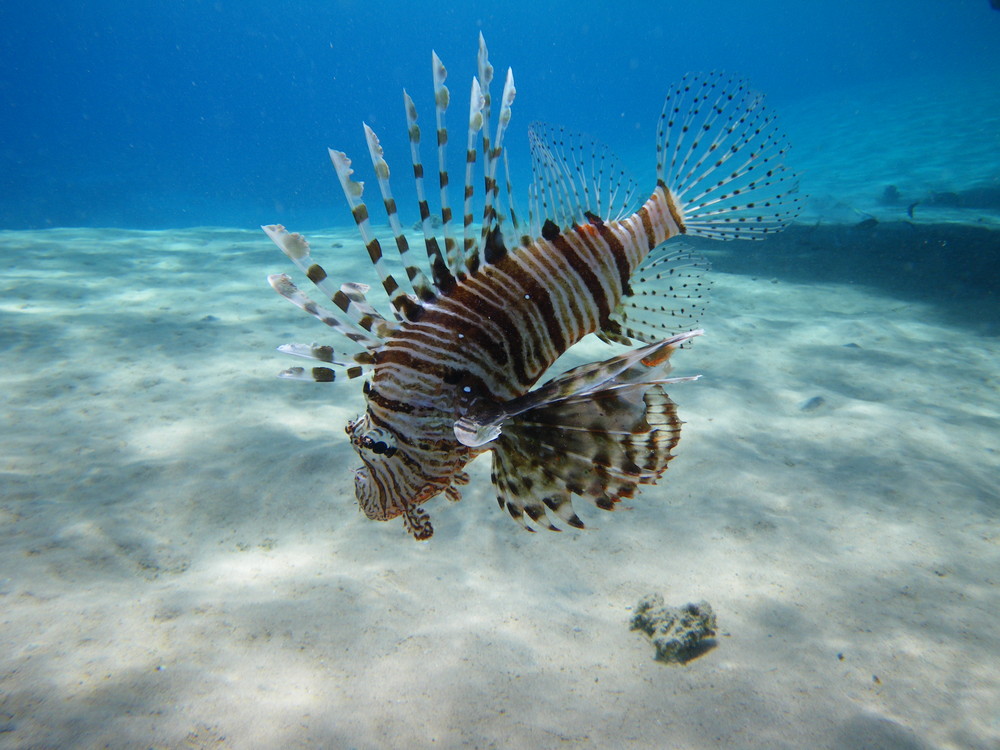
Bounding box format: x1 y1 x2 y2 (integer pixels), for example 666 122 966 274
263 34 798 539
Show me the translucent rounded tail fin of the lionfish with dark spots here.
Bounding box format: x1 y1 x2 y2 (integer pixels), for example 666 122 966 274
647 73 800 240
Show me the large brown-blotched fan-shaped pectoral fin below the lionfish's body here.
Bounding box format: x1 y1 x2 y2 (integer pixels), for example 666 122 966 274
455 331 700 528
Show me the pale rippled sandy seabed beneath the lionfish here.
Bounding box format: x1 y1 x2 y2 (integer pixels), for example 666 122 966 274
0 229 1000 750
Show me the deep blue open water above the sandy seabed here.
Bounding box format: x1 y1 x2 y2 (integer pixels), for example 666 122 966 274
0 0 1000 229
